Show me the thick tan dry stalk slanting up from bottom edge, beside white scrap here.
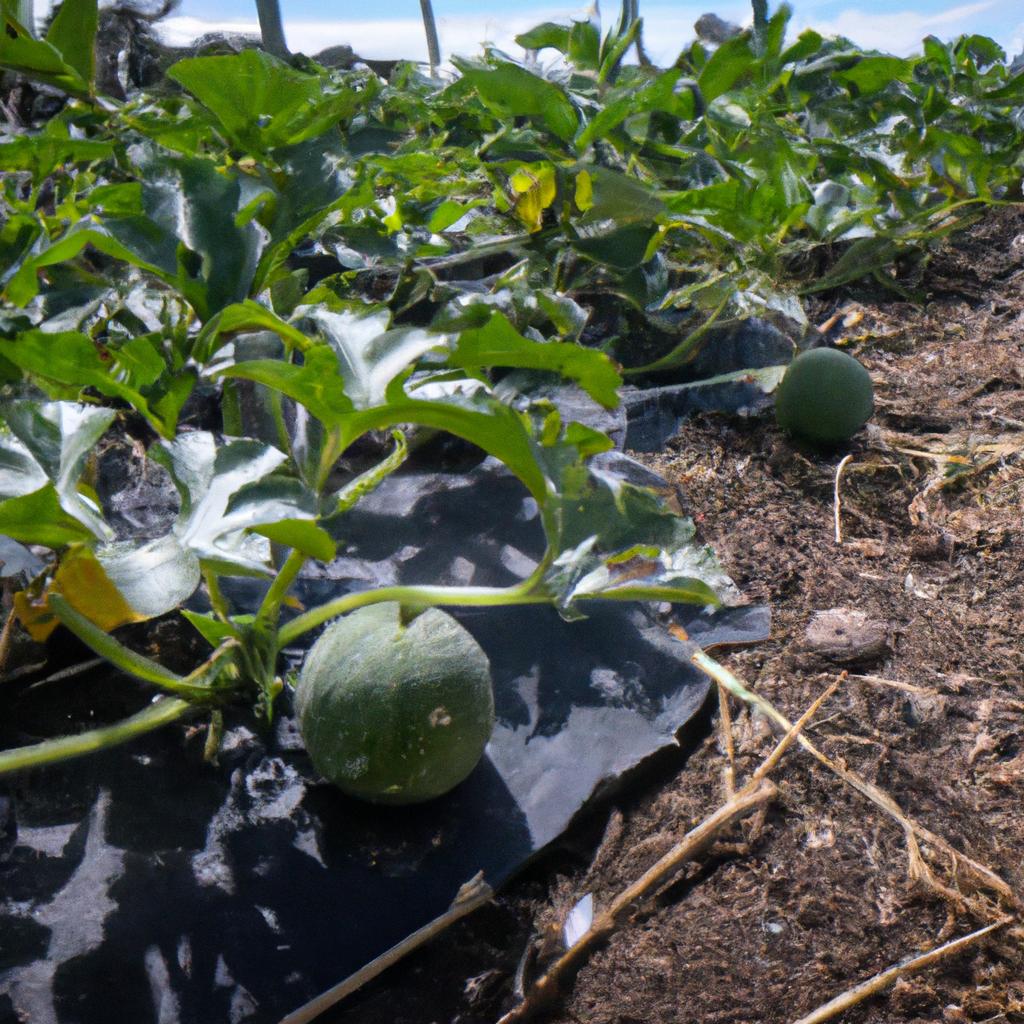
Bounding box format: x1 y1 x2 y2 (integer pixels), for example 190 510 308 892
498 673 846 1024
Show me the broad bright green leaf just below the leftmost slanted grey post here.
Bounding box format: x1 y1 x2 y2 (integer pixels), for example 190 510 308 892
167 50 376 155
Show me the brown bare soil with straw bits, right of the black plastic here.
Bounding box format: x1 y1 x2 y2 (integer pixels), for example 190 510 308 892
325 210 1024 1024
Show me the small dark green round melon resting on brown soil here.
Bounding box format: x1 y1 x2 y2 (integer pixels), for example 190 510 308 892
775 348 874 444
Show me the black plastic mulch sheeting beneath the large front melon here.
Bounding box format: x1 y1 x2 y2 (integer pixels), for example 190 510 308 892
0 453 767 1024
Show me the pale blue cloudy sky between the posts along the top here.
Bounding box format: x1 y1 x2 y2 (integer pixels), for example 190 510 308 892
153 0 1024 62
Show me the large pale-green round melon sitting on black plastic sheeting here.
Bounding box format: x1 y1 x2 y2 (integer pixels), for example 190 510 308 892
295 603 495 804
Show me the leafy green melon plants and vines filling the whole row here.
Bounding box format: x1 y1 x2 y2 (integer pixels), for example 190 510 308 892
0 0 1024 772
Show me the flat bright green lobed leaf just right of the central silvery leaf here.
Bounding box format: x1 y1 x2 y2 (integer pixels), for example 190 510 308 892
449 311 622 409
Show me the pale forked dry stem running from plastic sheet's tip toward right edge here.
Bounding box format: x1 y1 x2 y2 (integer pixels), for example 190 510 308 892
688 647 1020 906
